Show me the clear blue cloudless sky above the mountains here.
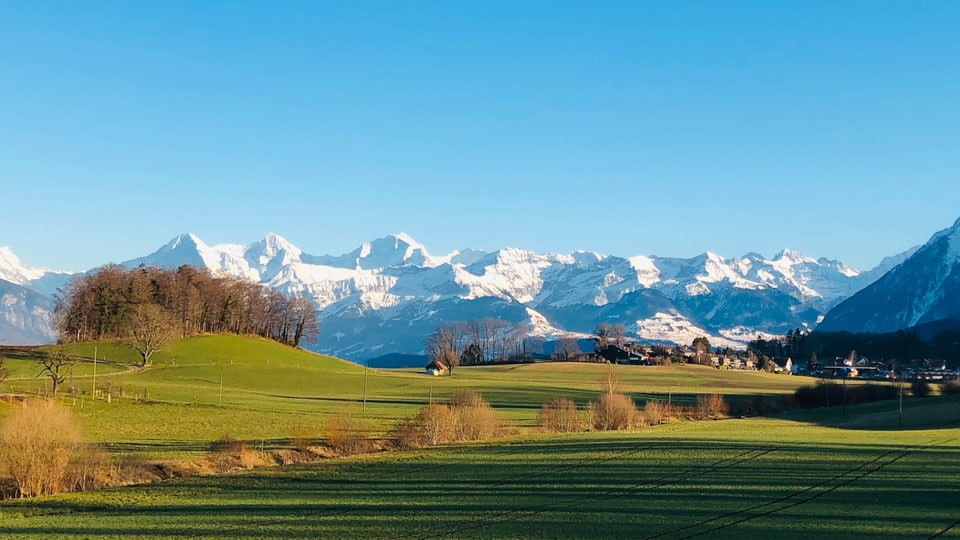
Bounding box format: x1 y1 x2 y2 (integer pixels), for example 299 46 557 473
0 0 960 270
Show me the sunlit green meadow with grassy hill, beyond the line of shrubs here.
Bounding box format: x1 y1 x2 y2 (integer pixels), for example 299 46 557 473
0 336 811 457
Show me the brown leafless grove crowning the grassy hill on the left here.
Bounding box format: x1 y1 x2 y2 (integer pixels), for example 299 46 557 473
54 265 319 365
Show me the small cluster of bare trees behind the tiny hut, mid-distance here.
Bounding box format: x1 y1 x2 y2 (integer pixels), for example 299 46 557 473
424 317 543 367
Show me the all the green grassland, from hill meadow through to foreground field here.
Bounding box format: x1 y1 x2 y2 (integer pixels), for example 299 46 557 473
0 336 960 539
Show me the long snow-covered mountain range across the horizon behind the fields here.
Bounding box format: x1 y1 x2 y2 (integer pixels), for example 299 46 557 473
0 234 923 361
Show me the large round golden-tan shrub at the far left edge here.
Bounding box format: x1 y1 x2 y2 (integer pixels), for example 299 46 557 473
0 401 84 497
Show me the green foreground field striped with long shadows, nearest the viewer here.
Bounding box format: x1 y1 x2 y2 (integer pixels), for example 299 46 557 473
0 419 960 539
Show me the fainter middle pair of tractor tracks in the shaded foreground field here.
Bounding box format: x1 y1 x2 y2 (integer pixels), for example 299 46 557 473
400 445 775 539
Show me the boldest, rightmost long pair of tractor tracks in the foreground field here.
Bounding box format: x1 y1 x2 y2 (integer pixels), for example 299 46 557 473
646 439 960 540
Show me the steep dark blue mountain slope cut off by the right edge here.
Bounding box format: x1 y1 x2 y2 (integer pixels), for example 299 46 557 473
820 216 960 332
